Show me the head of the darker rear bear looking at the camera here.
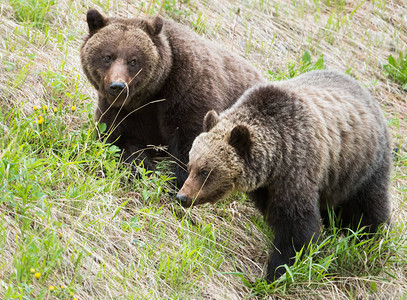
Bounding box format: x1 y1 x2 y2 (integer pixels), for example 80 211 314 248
81 10 171 108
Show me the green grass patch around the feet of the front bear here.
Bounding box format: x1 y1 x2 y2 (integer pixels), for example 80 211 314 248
250 217 407 296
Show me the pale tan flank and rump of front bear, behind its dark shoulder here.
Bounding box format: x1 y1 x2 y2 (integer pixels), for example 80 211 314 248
281 71 390 203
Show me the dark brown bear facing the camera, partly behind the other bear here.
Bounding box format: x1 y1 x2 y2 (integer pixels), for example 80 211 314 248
81 10 264 186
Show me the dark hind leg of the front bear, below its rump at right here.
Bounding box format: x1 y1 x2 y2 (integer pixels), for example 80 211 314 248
340 164 390 233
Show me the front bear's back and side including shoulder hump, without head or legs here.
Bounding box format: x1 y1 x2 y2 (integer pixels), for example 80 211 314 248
222 71 390 203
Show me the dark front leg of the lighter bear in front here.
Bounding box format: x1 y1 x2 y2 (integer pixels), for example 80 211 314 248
266 195 320 282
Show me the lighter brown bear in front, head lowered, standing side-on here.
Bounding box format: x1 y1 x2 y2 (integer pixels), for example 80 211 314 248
177 71 391 281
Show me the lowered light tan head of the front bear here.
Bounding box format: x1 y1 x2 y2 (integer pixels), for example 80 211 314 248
177 110 252 207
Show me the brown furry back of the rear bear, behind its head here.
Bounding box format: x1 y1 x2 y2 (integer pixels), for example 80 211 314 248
159 19 266 109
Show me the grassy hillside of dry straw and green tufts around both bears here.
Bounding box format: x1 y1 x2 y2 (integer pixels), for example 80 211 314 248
0 0 407 299
